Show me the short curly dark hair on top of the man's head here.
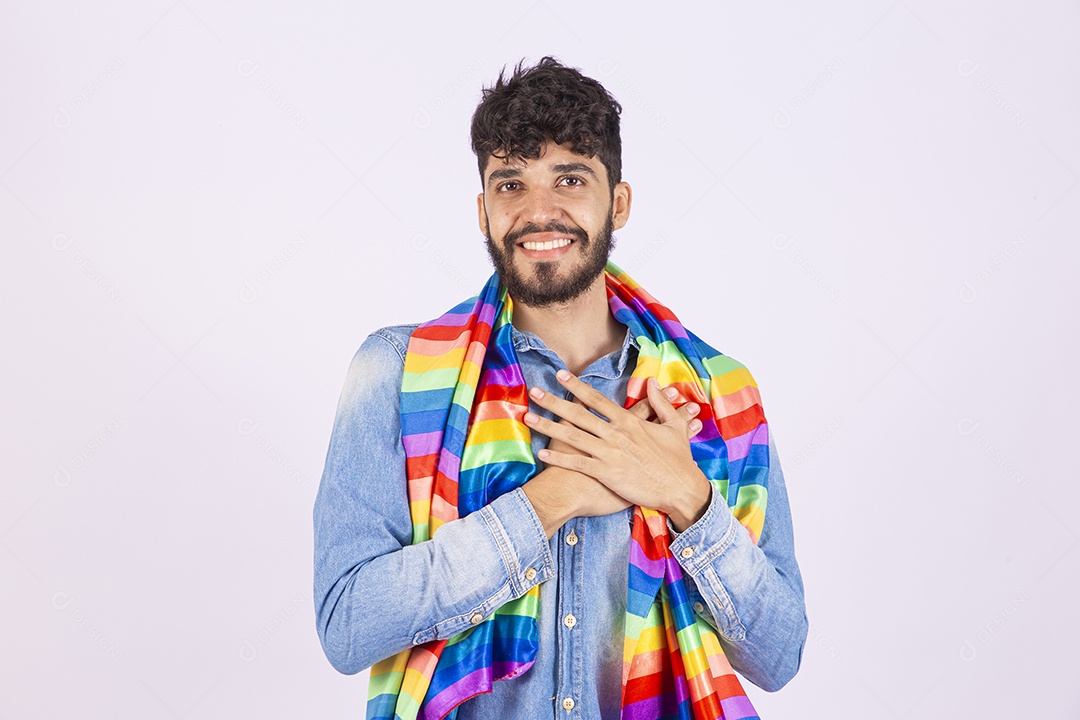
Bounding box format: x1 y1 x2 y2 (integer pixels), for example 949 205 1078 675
472 56 622 192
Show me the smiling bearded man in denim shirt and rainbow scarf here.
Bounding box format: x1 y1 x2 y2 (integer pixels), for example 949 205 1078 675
314 57 807 719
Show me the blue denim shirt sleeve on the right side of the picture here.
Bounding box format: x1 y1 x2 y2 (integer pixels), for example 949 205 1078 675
669 433 809 692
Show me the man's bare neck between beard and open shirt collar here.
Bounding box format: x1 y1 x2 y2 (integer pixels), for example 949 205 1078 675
513 267 626 375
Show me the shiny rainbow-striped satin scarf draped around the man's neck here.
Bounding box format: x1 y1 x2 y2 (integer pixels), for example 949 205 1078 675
367 262 769 720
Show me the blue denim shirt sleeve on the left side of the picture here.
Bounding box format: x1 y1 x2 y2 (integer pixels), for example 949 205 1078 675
312 328 555 675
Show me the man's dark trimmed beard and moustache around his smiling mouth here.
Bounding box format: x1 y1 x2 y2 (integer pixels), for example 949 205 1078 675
486 213 615 308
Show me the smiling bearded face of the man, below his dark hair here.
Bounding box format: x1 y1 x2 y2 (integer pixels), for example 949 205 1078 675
476 142 631 308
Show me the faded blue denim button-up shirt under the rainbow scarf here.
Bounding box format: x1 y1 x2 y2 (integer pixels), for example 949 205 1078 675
313 324 807 720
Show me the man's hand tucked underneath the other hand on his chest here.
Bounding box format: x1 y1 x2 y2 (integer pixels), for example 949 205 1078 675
523 388 701 538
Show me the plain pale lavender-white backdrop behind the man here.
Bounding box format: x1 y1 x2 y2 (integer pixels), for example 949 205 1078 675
0 0 1080 720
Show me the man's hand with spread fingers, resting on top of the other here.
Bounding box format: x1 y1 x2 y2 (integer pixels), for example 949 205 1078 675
525 371 712 531
